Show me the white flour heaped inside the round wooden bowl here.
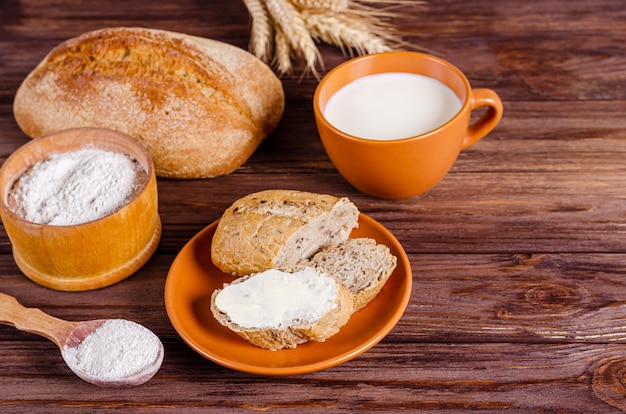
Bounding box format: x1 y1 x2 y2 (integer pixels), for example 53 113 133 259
9 148 146 226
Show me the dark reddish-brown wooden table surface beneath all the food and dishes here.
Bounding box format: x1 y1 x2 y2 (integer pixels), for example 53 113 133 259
0 0 626 413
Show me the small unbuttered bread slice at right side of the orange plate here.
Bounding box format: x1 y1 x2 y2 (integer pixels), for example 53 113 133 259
303 238 398 311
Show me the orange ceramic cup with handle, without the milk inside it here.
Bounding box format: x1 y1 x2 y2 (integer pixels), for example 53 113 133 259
313 51 503 199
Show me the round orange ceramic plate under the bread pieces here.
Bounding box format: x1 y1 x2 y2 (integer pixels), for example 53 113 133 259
165 214 412 375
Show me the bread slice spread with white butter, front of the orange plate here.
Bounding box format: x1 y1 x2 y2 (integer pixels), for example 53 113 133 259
211 268 354 350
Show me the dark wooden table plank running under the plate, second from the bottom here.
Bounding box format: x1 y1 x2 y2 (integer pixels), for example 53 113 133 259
0 252 626 345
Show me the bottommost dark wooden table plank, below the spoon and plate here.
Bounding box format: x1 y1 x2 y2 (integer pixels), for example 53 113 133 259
0 341 626 413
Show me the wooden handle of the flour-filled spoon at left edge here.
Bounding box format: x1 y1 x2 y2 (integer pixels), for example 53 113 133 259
0 292 79 348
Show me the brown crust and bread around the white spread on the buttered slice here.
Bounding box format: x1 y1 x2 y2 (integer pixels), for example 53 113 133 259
206 275 354 351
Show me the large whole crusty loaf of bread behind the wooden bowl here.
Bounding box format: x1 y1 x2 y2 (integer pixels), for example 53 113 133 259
13 27 284 178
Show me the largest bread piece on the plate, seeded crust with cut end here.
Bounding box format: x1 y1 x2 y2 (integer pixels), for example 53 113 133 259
211 190 359 276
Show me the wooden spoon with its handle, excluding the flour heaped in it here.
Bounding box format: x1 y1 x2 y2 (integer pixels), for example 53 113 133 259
0 293 164 387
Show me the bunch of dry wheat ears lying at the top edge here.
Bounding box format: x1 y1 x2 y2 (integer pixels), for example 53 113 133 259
244 0 419 77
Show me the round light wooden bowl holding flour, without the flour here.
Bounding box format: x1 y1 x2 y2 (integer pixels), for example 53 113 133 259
0 128 161 291
